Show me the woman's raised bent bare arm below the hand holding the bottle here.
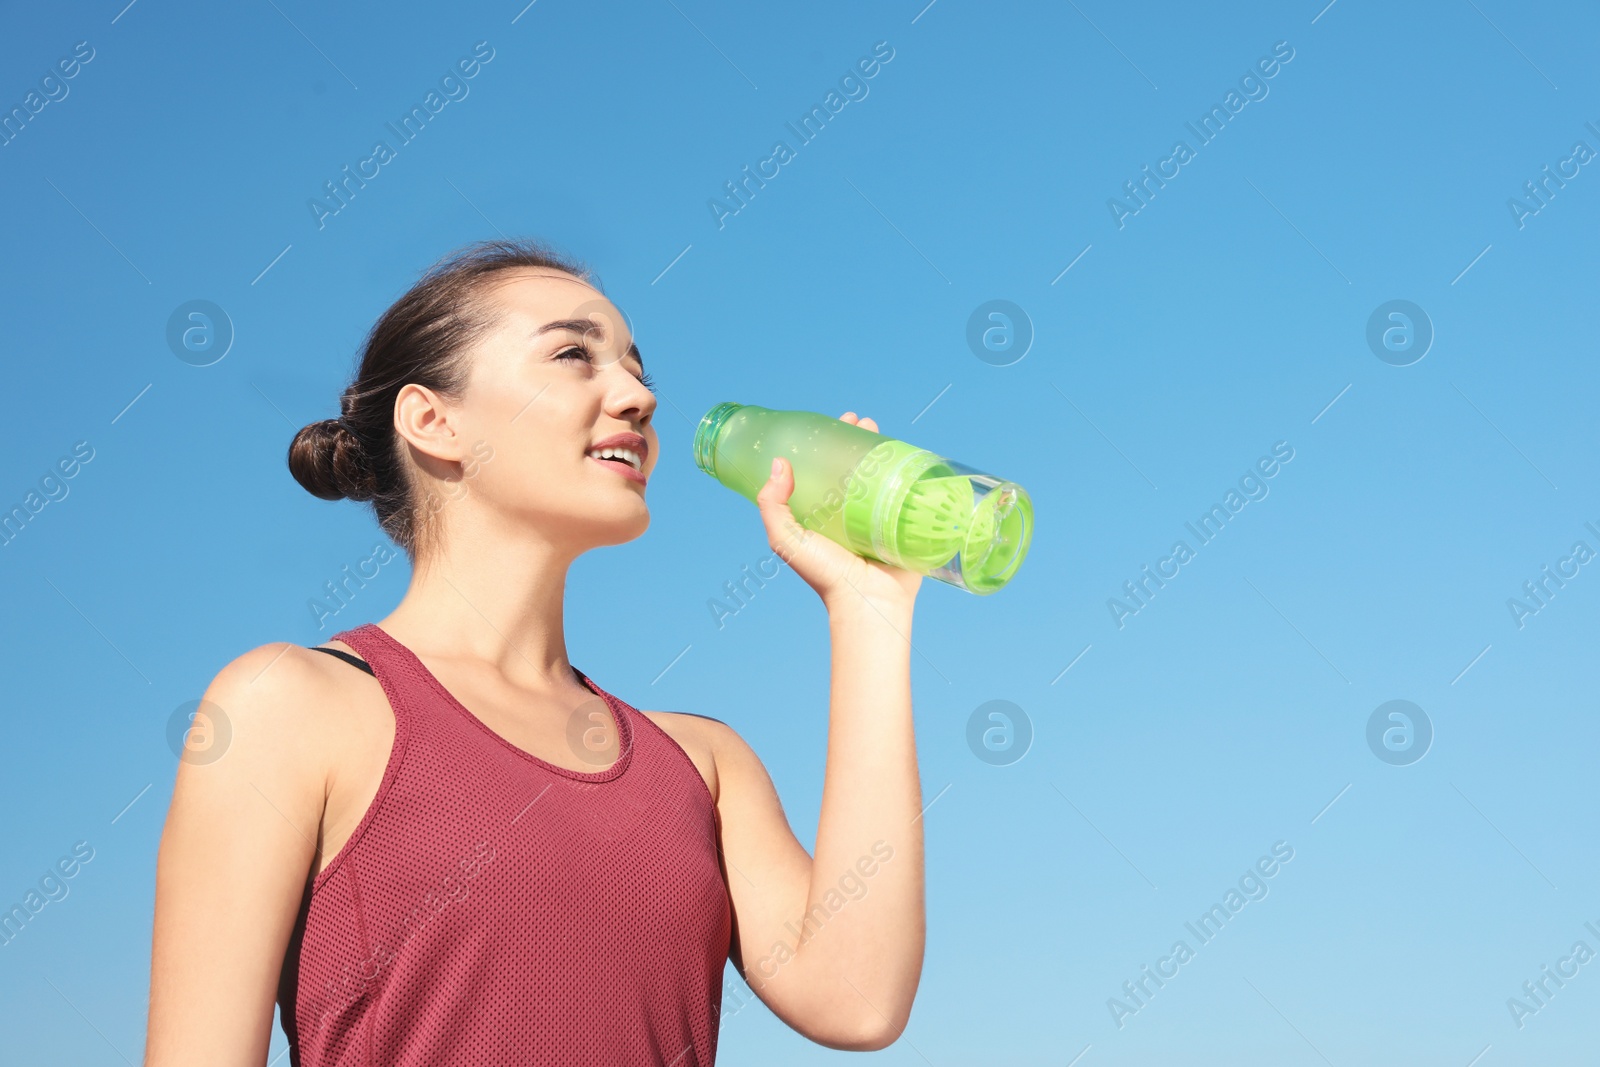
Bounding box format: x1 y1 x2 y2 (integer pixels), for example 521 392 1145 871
712 601 925 1049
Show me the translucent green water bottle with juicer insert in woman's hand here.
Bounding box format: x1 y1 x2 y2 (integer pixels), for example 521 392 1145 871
694 403 1034 595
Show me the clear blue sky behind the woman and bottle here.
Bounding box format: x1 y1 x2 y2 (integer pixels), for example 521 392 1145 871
0 0 1600 1067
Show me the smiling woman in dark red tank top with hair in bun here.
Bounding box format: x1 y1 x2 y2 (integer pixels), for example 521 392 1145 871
146 242 923 1067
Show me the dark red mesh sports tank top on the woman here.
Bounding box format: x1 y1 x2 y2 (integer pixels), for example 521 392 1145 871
278 622 731 1067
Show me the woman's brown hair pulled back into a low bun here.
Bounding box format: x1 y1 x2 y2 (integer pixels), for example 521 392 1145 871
288 238 597 563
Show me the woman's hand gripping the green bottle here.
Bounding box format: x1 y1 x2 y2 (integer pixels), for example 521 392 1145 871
755 411 922 613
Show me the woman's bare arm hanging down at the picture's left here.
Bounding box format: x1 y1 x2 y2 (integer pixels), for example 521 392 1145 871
144 643 326 1067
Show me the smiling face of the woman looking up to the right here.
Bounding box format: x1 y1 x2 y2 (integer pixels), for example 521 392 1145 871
444 269 658 552
